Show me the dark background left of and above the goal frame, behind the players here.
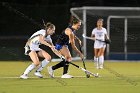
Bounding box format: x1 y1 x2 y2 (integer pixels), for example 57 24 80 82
0 0 140 60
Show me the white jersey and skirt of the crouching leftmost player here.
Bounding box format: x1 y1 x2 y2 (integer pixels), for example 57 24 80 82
25 29 52 55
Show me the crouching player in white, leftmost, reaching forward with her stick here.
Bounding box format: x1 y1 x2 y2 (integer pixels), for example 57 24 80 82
20 23 62 79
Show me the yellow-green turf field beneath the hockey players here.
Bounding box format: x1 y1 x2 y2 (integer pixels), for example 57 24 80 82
0 61 140 93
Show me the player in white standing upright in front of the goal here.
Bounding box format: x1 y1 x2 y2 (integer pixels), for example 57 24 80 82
91 19 109 69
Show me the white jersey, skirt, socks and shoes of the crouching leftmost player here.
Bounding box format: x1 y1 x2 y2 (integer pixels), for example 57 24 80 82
20 29 52 79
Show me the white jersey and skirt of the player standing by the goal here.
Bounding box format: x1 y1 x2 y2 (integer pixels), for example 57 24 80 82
92 27 107 48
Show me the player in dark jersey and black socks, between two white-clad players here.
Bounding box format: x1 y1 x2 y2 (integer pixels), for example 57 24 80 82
48 18 83 78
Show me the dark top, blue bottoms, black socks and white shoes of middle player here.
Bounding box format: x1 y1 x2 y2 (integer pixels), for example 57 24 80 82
48 26 74 78
